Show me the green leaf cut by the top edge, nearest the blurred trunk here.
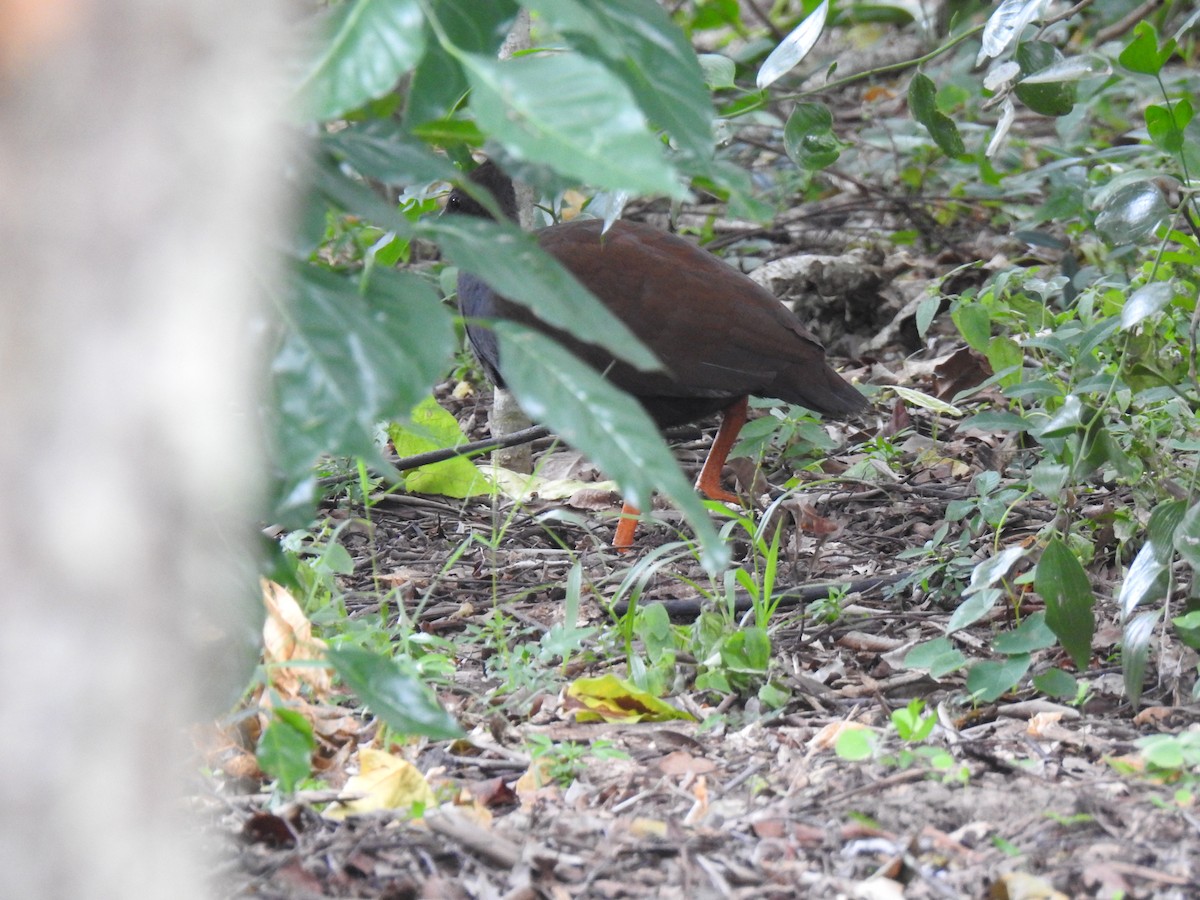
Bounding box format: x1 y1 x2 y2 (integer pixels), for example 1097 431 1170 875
298 0 425 120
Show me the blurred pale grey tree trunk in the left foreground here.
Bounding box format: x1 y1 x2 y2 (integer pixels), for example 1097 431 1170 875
0 0 282 900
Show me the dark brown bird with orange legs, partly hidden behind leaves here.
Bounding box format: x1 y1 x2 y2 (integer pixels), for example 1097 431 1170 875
446 162 866 547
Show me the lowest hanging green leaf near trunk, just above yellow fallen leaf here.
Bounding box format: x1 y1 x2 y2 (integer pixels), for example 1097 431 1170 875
325 647 463 740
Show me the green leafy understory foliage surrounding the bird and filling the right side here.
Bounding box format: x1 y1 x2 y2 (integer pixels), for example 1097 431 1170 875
265 0 1200 768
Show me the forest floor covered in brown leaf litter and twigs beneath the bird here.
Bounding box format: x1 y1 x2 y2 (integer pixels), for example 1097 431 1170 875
196 165 1200 900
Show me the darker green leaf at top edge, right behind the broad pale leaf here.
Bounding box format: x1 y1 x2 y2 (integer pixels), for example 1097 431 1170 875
524 0 713 157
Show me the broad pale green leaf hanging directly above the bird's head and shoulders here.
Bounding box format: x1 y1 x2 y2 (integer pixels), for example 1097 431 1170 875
461 54 698 198
